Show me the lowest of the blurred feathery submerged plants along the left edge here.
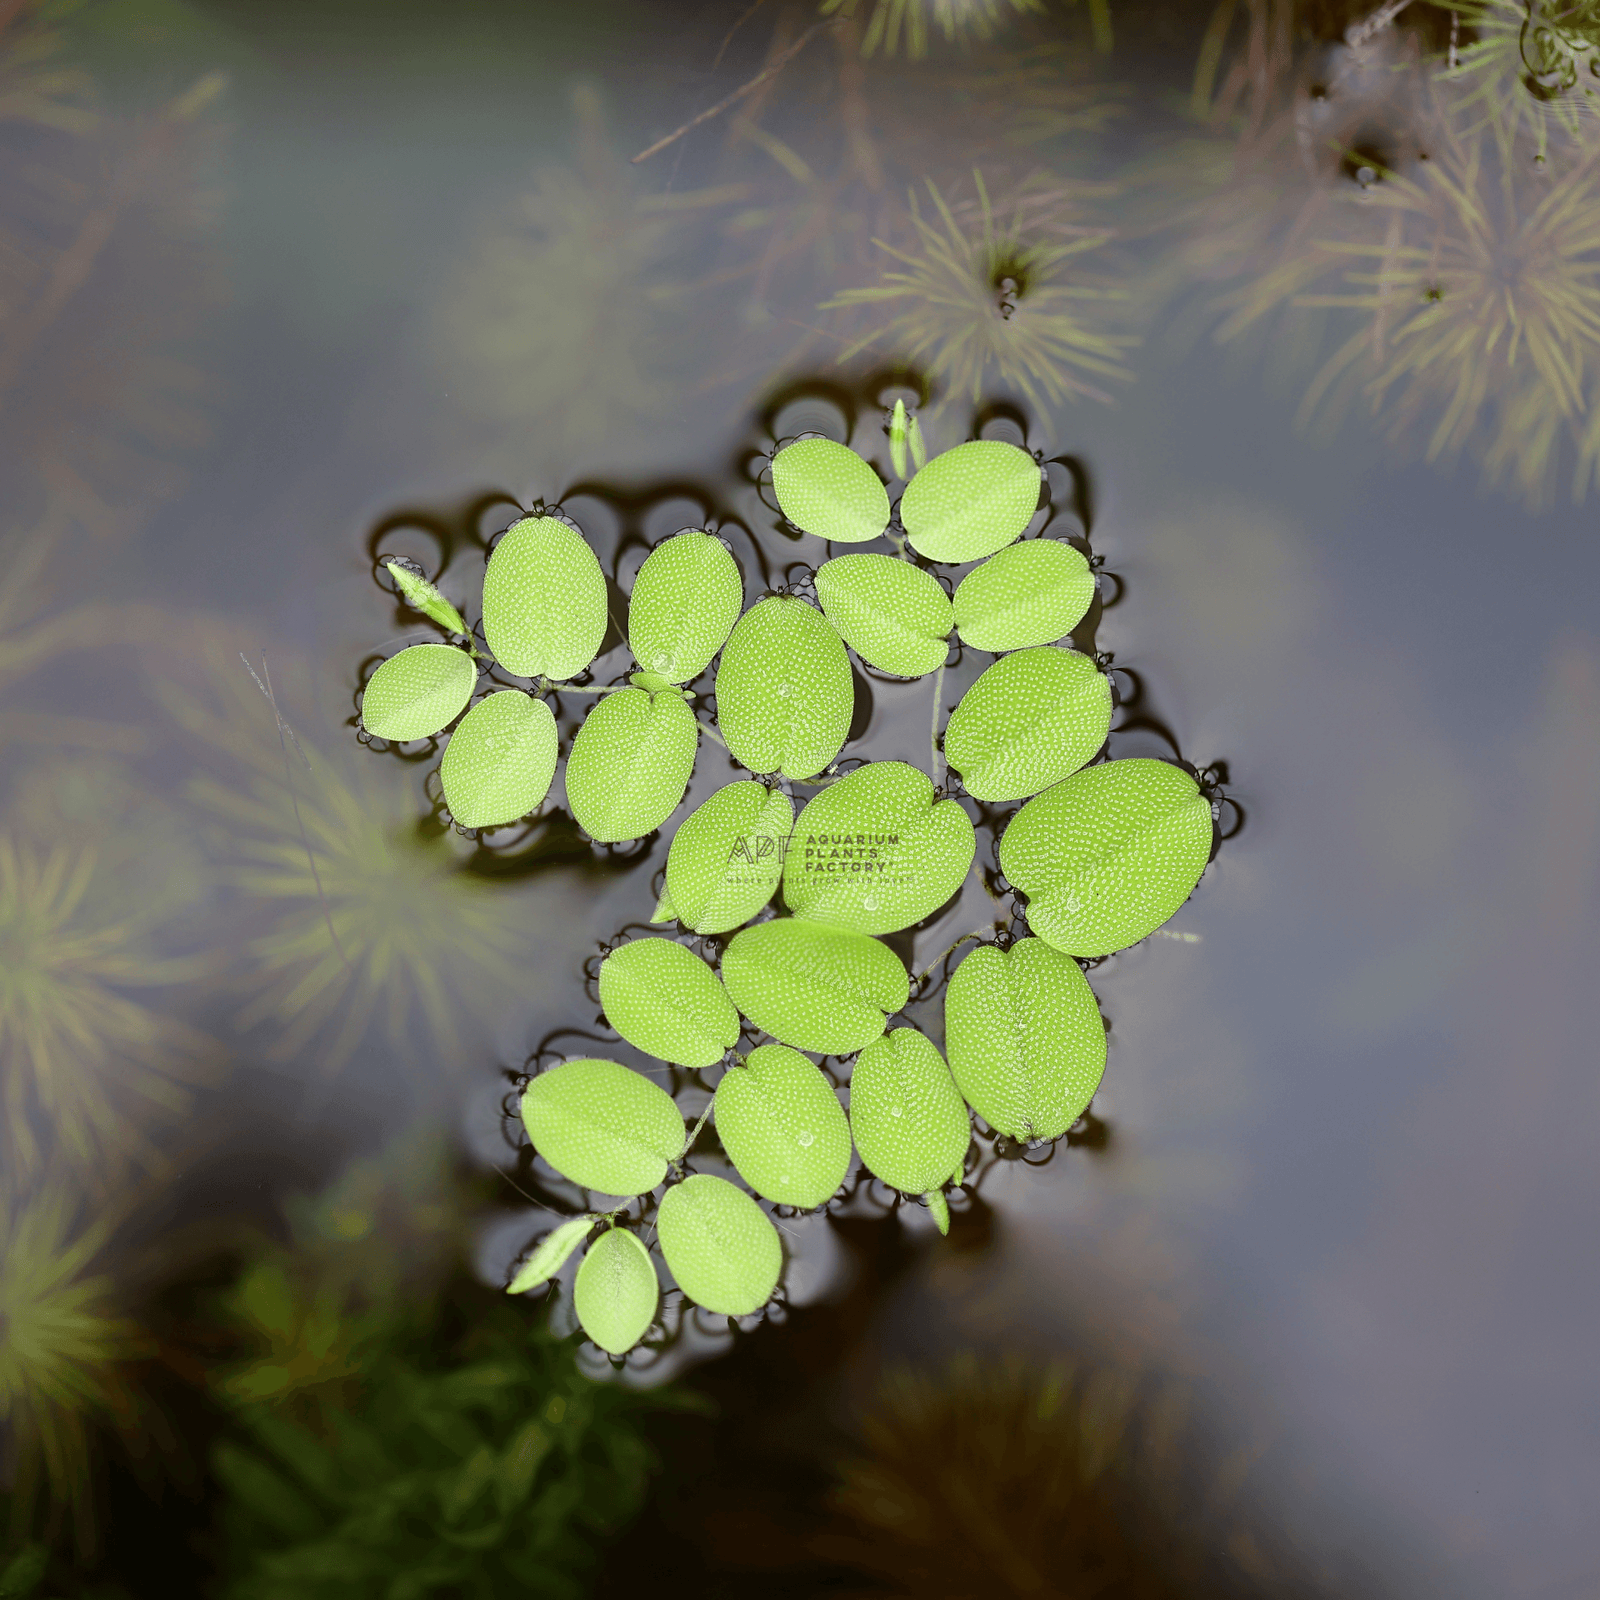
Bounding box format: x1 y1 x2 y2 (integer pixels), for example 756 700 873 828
0 1181 144 1542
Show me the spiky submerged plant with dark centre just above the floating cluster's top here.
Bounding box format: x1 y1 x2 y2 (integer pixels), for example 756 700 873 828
824 173 1136 405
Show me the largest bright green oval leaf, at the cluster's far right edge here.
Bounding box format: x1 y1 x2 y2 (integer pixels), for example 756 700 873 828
1000 758 1211 955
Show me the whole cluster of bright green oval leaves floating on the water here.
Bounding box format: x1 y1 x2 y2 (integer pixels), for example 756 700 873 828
360 403 1214 1355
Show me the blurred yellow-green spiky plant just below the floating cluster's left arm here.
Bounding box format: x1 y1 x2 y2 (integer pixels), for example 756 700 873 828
154 626 536 1085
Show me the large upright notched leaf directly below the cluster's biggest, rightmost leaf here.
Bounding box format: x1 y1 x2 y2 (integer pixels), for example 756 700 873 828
944 939 1106 1141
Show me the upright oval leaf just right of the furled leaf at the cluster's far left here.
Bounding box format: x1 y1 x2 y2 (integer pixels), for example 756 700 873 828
483 517 606 683
